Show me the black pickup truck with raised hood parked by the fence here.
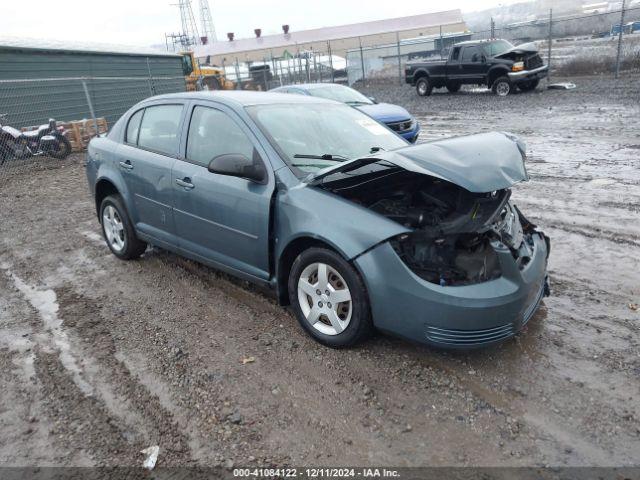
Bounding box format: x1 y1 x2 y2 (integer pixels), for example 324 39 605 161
405 40 549 96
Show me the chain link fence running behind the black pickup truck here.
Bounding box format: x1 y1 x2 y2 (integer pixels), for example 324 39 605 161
224 6 640 90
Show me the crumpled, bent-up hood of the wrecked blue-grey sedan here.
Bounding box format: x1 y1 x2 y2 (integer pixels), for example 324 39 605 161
305 132 529 193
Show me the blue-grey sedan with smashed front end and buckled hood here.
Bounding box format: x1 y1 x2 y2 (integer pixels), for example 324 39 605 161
86 91 549 348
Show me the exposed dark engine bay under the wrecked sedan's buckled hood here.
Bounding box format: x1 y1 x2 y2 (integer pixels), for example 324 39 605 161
321 167 535 286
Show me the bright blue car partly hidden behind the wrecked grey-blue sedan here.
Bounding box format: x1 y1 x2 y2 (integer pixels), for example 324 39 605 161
271 83 420 143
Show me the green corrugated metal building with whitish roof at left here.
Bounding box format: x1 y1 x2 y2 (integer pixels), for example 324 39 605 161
0 38 185 127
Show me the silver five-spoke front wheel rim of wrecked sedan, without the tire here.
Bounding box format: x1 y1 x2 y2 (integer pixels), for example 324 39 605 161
298 262 353 335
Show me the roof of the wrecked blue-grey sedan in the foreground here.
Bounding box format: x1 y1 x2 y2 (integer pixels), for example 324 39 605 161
145 90 340 107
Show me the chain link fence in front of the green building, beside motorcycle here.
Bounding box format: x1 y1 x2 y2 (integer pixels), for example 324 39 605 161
0 77 186 181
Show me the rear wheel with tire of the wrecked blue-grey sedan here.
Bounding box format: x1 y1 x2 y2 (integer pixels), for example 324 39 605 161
100 195 147 260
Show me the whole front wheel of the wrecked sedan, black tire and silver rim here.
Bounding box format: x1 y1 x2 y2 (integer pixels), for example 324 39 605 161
288 248 373 348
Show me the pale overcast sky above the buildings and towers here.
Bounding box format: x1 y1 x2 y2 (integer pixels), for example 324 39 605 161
0 0 515 46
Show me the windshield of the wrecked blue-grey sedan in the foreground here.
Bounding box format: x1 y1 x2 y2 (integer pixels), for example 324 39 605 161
247 102 407 178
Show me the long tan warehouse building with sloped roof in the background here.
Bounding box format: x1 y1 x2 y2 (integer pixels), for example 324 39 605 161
195 10 467 65
